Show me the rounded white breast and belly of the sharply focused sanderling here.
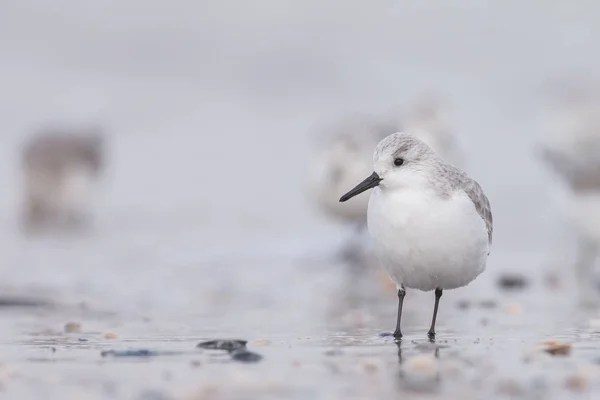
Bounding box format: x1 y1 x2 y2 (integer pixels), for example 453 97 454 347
368 188 489 291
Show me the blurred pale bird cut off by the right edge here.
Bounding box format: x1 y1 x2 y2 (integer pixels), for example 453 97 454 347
538 91 600 303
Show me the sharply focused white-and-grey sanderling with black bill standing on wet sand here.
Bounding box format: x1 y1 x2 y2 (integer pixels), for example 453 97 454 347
339 133 493 338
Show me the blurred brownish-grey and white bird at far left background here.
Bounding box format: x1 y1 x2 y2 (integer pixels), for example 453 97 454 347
21 129 104 232
